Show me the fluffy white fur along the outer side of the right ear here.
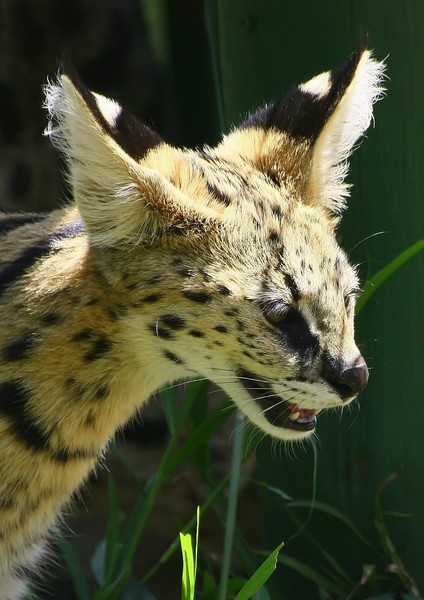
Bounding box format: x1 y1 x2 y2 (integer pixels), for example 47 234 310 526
306 50 385 213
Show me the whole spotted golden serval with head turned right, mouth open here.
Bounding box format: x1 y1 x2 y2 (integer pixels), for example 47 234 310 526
0 50 383 600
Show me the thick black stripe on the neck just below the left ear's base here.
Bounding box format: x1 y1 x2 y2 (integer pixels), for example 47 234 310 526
0 219 85 296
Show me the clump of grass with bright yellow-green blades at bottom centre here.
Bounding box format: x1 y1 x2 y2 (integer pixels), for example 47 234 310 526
58 382 282 600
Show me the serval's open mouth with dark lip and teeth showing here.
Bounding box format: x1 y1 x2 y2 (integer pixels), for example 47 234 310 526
237 369 319 432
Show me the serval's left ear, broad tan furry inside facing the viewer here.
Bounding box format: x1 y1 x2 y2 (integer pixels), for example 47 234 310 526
46 75 219 247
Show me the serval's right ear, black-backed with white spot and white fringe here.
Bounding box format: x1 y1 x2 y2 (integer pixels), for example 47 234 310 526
222 50 385 213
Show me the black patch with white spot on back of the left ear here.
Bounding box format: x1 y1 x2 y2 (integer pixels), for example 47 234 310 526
46 74 162 161
